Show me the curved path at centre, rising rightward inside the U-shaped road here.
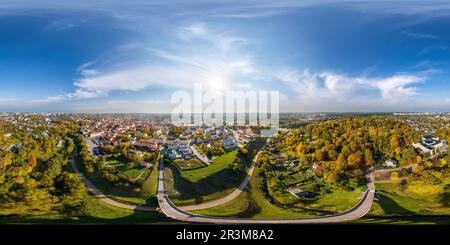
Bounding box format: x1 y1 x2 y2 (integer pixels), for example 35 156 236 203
179 152 260 211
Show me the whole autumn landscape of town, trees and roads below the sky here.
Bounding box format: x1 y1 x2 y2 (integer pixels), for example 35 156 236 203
0 113 450 224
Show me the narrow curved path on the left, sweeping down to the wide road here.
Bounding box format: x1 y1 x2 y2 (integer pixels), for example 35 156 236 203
70 158 156 212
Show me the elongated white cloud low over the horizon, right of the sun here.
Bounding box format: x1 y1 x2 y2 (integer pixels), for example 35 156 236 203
277 69 425 110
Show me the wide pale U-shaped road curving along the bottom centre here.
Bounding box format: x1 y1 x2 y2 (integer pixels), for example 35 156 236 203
158 155 375 224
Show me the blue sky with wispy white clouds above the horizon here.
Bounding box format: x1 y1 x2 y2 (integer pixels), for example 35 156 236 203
0 0 450 112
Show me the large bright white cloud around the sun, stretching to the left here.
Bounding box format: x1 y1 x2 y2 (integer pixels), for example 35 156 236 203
74 23 257 95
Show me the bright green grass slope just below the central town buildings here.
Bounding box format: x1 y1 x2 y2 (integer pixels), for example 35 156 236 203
181 150 237 182
